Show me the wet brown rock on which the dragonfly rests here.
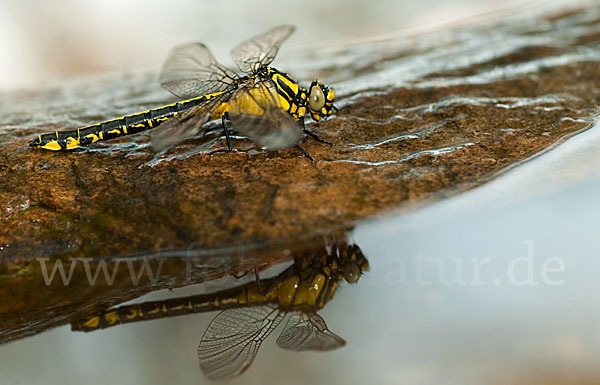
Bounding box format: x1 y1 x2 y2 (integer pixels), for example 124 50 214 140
0 9 600 263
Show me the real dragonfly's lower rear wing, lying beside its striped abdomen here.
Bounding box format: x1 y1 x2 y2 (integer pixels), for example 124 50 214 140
150 92 232 151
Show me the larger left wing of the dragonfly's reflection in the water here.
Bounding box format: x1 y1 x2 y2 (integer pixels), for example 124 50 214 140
198 305 285 380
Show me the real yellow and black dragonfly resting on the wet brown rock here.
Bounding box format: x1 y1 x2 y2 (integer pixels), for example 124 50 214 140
30 25 335 158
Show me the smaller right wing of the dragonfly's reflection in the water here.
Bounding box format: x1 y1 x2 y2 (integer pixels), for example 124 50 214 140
277 313 346 352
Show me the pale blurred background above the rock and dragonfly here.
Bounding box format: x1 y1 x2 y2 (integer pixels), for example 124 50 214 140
0 0 576 90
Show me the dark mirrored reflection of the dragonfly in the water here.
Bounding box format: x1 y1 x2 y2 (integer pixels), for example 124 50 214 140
71 240 369 380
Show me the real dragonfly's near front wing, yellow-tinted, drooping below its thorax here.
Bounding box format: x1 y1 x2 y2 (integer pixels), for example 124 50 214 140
229 80 301 150
